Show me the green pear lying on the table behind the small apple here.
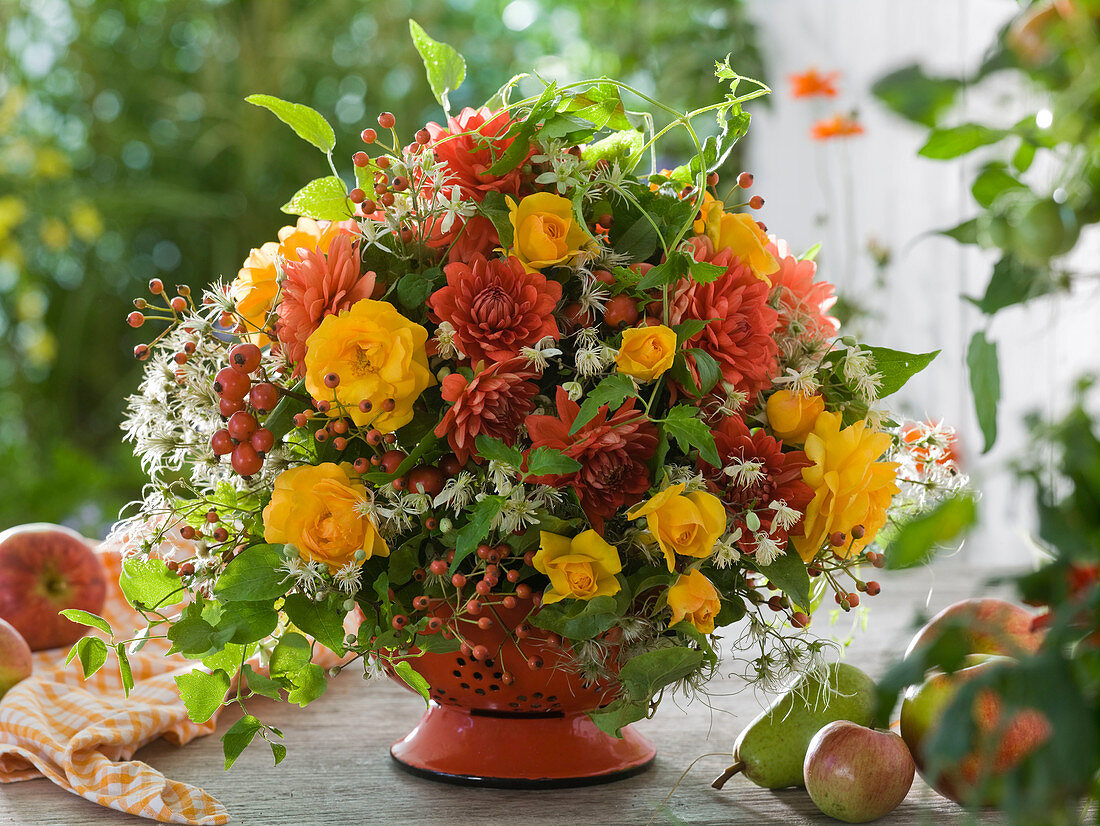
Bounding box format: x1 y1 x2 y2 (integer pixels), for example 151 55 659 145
712 662 875 789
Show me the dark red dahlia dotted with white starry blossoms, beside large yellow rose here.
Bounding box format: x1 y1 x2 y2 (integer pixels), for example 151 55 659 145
699 416 813 553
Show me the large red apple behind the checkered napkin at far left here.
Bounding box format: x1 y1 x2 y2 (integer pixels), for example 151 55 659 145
0 524 107 651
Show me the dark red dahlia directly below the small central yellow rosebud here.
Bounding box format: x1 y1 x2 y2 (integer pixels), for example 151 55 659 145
527 387 657 531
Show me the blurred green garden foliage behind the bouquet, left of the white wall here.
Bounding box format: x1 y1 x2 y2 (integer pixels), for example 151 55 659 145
0 0 763 533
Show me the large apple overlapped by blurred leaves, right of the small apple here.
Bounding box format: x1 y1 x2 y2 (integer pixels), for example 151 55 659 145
901 654 1052 805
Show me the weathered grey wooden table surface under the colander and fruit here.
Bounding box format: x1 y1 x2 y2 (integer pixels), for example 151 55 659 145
0 563 1000 826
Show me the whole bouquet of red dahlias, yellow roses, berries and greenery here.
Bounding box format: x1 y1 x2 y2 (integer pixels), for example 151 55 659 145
76 23 961 768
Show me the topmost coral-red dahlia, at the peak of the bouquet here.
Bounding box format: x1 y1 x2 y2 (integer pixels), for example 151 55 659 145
425 107 535 202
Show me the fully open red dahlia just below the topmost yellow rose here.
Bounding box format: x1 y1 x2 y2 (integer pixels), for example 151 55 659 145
428 255 561 364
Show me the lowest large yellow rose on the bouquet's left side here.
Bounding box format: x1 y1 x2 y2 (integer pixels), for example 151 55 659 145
264 462 389 572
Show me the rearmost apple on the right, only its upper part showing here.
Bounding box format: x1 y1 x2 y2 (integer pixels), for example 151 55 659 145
905 597 1043 657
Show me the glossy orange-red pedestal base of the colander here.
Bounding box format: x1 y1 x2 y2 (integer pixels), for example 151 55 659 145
389 702 657 789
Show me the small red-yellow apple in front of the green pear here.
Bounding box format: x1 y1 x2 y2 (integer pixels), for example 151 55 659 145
802 720 915 823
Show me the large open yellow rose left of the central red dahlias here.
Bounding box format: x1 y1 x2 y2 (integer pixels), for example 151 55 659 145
305 298 435 433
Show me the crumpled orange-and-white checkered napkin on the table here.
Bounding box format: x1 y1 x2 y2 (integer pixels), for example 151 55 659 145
0 549 347 825
